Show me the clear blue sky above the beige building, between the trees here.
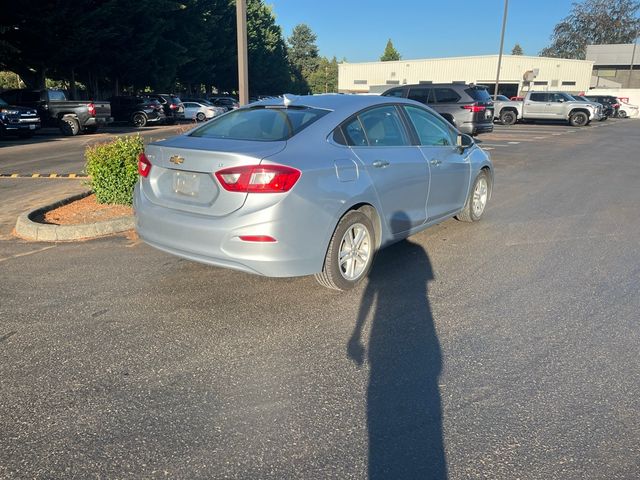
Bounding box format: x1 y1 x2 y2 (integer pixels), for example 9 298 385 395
272 0 584 62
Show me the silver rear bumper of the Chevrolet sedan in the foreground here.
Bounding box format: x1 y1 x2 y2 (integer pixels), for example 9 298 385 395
133 183 326 277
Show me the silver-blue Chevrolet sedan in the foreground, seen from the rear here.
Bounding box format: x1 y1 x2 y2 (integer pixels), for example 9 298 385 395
134 95 493 290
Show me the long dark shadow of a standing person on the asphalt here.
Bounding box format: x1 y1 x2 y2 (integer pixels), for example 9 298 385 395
347 219 447 480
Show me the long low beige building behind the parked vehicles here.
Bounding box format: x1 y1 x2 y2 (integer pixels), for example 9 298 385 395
338 55 593 97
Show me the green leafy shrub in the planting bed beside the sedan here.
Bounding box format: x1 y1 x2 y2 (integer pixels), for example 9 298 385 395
84 135 144 205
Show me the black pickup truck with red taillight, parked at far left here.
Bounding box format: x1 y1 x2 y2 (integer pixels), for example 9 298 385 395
0 89 113 135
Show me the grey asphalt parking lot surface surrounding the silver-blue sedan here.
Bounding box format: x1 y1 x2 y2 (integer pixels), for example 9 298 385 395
0 119 640 480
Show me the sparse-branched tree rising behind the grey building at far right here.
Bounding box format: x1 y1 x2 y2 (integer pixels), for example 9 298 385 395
540 0 640 60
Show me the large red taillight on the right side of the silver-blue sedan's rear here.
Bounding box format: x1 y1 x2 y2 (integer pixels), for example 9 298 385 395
216 165 300 193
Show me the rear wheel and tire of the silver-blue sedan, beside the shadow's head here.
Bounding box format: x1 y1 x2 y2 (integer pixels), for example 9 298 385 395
315 210 376 290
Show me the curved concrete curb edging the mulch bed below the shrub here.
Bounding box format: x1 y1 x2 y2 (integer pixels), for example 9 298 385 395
15 192 135 242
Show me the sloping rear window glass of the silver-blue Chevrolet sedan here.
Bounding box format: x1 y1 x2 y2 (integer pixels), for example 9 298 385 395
190 106 329 142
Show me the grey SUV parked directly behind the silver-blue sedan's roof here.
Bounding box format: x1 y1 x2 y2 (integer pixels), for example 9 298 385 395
382 83 493 135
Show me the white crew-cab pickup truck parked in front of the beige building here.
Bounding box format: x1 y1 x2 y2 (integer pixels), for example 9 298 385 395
494 92 602 127
